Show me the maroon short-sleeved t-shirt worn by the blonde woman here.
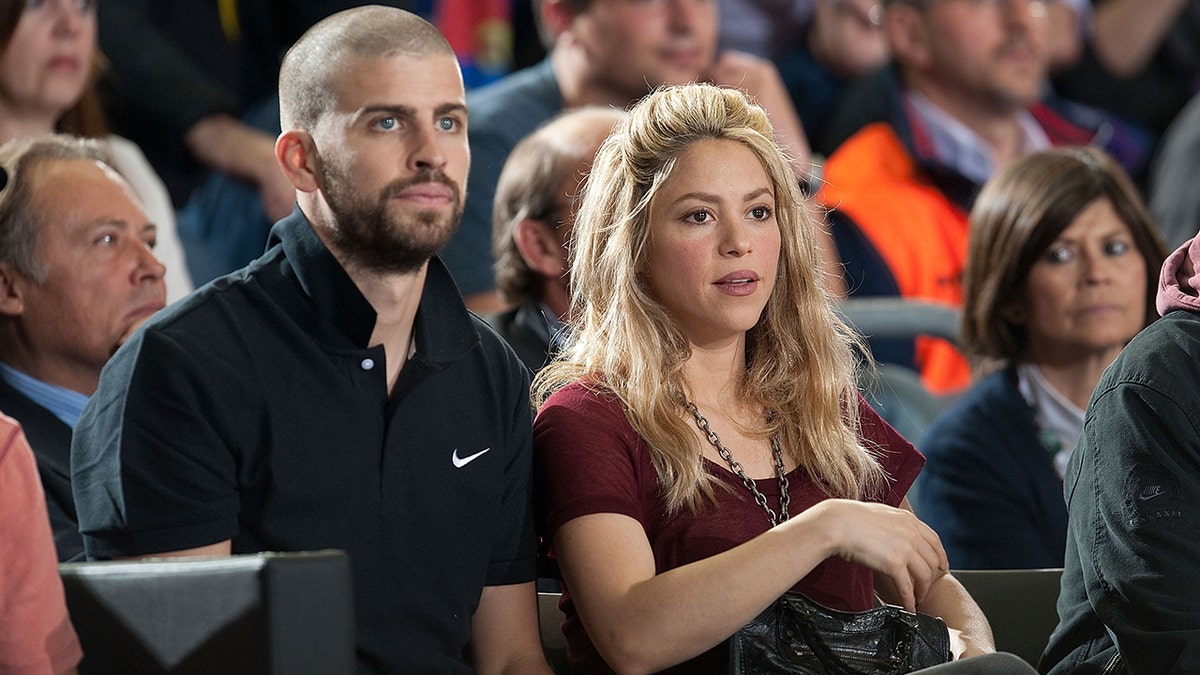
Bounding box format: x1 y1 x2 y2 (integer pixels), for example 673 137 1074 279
534 382 925 671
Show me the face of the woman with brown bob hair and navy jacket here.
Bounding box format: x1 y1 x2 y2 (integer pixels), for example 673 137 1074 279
1013 198 1146 364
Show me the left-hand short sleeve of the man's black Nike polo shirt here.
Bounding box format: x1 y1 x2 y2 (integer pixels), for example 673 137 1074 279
71 330 249 558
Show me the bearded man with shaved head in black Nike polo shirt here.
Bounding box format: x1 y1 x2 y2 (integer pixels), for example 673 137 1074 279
72 6 548 673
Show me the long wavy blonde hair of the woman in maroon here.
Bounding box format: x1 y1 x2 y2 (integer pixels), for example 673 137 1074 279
533 84 884 513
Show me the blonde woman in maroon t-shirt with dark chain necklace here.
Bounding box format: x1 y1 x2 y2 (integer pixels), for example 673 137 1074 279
534 84 1022 673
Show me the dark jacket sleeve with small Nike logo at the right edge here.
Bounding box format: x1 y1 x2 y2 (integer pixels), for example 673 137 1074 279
1068 379 1200 673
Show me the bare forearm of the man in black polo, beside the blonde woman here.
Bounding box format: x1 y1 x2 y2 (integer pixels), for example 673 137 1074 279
470 581 552 675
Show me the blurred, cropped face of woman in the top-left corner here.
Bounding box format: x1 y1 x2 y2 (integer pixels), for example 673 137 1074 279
0 0 96 124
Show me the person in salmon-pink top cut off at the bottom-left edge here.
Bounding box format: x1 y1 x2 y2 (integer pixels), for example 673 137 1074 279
0 413 83 675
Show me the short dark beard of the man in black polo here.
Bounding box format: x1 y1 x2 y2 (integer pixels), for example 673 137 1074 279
323 162 463 274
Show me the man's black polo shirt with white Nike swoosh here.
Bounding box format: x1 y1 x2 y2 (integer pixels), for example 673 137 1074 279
72 210 534 673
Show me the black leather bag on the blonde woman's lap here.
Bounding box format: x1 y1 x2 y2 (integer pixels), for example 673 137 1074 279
728 593 950 675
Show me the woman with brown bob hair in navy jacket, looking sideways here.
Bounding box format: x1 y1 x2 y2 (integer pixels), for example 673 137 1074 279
916 148 1165 569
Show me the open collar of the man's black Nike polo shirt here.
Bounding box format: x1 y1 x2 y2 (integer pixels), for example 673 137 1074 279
266 207 479 363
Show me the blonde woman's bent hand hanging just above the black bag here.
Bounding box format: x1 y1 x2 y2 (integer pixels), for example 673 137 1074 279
796 500 949 611
